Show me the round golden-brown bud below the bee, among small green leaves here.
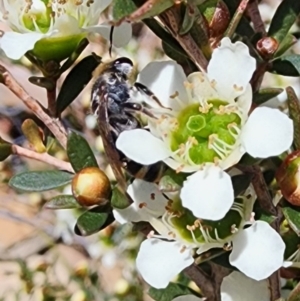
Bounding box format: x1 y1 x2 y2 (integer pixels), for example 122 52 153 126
72 167 111 206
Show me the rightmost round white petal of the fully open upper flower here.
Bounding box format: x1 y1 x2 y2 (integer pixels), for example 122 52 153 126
241 107 293 158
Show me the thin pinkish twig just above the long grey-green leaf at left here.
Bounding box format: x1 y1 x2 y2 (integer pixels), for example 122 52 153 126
12 144 74 172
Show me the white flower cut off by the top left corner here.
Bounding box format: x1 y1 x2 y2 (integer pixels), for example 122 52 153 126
0 0 131 59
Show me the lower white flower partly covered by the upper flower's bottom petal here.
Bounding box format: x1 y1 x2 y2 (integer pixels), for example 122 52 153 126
113 180 285 288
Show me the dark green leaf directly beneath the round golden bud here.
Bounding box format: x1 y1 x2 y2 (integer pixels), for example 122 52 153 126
74 206 115 236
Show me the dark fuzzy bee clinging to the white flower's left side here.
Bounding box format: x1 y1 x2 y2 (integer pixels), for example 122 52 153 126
91 57 165 191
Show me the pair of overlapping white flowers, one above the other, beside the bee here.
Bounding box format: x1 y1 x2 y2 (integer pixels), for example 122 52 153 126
114 38 293 292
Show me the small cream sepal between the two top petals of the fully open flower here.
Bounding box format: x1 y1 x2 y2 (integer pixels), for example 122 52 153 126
187 72 219 102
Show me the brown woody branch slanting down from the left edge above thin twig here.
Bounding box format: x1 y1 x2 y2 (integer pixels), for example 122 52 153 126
0 65 67 148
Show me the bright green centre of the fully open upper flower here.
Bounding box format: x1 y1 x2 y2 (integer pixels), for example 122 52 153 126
171 100 241 165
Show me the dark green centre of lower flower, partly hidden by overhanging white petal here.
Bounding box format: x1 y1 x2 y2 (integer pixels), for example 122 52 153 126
168 198 244 244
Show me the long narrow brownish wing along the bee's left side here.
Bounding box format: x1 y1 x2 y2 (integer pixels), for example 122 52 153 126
98 94 132 203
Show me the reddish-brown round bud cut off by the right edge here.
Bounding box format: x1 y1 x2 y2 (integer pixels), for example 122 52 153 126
276 150 300 206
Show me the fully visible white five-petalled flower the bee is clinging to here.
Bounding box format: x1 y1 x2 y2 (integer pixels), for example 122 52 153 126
116 38 293 220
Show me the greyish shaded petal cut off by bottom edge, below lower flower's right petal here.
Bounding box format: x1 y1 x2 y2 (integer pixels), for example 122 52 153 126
221 271 270 301
